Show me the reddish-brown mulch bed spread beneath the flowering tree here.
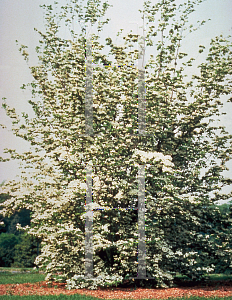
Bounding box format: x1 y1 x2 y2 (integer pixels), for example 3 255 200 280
0 280 232 299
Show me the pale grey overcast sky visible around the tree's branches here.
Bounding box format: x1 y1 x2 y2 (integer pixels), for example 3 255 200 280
0 0 232 202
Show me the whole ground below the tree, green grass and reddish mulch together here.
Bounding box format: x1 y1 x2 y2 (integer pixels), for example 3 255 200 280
0 268 232 300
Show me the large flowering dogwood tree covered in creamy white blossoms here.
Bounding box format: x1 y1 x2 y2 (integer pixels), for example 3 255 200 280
0 0 232 288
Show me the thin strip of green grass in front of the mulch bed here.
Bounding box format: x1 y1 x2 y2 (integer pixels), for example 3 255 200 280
0 294 232 300
